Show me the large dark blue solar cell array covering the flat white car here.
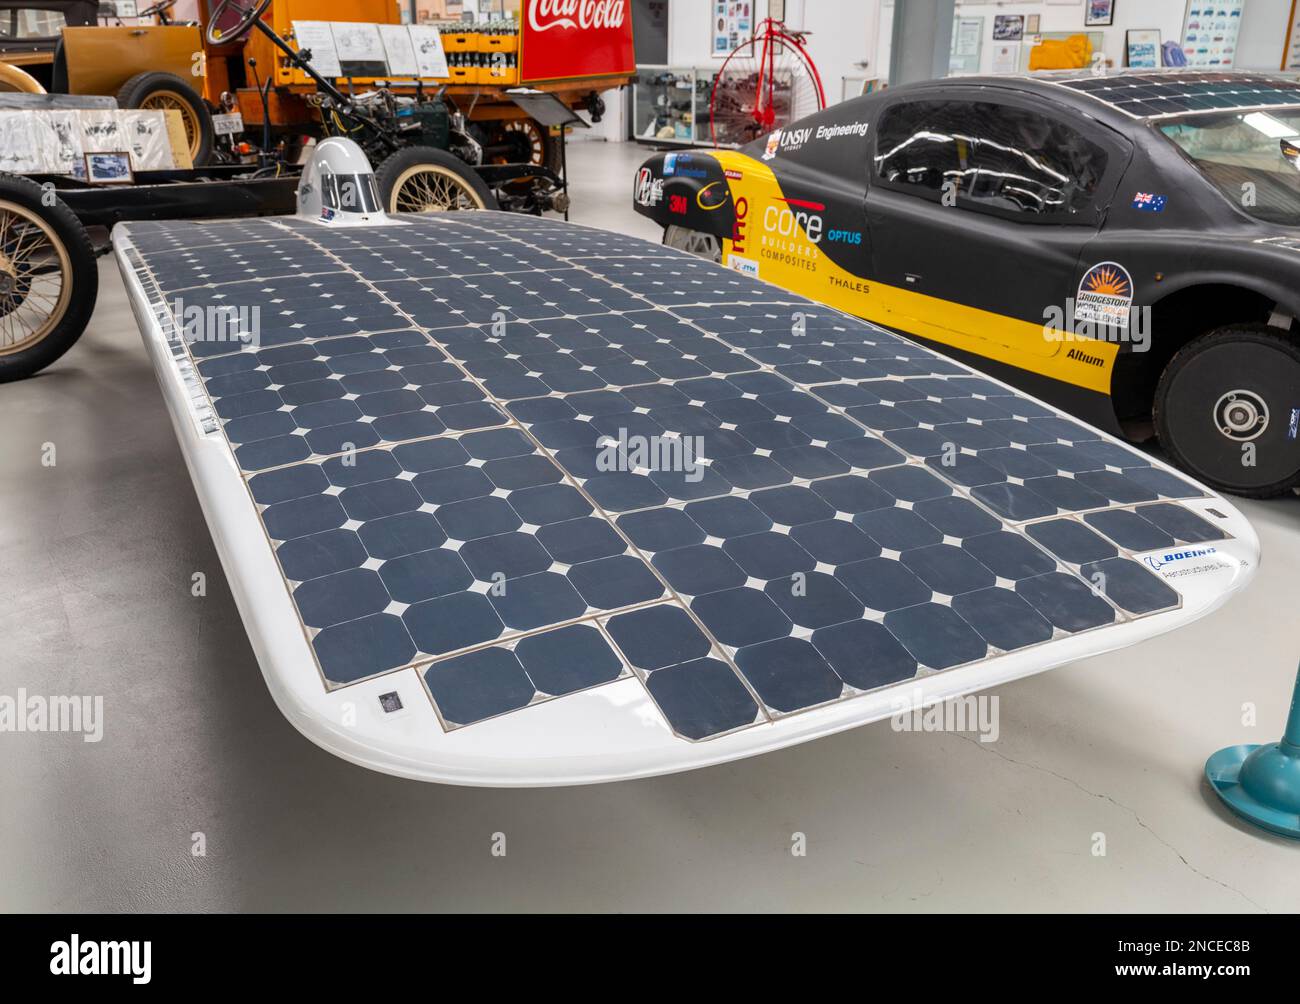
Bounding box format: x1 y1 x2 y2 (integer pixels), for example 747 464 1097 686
119 213 1223 740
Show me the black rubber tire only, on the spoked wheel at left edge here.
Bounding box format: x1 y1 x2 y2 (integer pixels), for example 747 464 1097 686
0 174 99 384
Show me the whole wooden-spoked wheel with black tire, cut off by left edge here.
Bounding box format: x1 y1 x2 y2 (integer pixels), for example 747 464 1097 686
0 174 99 381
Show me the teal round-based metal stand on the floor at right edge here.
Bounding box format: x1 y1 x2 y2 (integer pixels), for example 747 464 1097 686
1205 676 1300 839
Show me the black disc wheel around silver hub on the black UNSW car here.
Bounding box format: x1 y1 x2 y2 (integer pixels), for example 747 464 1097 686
1152 324 1300 498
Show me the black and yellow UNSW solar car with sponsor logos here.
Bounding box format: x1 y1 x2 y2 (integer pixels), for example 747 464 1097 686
634 72 1300 495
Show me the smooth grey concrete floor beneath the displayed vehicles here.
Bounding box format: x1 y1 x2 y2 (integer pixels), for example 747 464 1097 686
0 143 1300 912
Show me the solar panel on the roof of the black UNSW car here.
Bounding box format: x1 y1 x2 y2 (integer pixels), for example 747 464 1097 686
1048 70 1300 118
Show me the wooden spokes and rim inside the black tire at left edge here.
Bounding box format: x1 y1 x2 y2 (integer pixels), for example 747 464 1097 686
0 200 72 356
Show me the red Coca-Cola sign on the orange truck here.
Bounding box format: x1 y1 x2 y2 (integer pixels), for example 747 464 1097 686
519 0 636 83
